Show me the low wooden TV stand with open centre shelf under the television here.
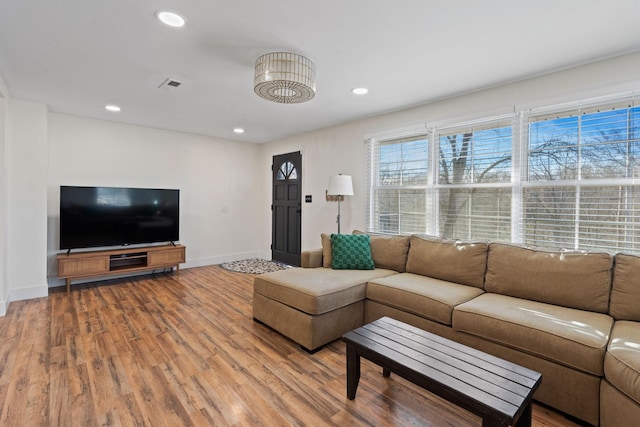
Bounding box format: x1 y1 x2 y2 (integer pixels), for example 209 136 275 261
58 246 186 292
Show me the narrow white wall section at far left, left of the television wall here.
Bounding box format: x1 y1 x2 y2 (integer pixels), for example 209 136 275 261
3 98 48 303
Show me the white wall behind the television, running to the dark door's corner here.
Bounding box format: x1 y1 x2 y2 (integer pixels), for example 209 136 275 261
47 113 265 285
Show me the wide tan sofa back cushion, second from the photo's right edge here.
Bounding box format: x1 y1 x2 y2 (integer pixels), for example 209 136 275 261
484 243 613 313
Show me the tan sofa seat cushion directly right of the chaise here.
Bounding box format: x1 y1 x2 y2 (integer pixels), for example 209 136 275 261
366 273 483 326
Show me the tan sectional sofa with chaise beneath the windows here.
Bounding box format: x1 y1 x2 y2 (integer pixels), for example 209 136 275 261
254 235 640 427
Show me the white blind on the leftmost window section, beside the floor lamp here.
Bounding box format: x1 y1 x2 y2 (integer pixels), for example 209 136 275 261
367 134 429 234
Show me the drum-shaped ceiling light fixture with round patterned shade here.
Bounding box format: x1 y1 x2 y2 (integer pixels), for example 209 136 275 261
253 52 316 104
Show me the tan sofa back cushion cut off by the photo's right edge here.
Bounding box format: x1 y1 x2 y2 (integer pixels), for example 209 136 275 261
609 254 640 321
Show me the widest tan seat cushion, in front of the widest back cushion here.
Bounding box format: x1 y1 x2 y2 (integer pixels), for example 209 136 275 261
453 293 613 375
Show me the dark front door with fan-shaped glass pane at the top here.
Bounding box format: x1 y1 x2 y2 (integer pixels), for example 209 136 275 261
271 151 302 266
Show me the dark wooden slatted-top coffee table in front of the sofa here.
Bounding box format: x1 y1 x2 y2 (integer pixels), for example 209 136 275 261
342 317 542 427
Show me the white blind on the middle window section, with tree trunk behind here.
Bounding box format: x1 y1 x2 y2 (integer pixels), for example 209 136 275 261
436 117 513 241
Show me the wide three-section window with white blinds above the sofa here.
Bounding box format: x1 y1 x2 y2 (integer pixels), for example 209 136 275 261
367 95 640 253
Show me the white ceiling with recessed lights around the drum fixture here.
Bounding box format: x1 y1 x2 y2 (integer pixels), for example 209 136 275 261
0 0 640 143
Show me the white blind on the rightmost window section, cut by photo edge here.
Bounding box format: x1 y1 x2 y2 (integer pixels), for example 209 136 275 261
523 102 640 252
